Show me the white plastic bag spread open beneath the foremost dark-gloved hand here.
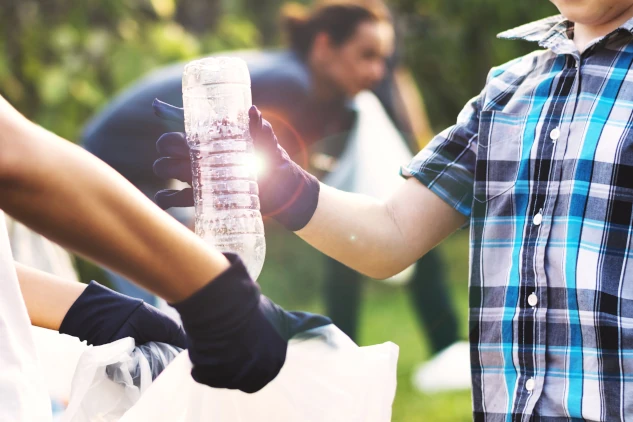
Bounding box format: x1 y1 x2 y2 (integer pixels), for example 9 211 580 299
121 325 398 422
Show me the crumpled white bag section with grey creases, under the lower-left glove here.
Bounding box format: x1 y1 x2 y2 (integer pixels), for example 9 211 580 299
62 337 182 422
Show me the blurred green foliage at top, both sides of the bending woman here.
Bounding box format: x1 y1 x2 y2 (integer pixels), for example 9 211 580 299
0 0 555 139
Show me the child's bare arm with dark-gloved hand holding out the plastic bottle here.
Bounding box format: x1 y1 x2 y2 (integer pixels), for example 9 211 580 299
154 101 477 278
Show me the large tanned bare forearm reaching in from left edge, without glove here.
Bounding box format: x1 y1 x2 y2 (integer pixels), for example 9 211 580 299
0 97 229 302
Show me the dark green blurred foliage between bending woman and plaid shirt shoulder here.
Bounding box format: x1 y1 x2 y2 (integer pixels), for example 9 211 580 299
389 0 558 131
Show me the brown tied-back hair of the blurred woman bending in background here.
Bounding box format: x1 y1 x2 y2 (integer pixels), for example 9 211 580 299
282 0 390 55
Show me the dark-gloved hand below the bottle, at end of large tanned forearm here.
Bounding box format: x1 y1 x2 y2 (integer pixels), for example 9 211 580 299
172 253 331 393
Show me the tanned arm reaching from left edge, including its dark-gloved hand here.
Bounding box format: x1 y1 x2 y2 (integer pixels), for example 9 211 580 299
0 97 298 392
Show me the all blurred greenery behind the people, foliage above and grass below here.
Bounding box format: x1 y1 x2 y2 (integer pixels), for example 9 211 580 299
0 0 556 422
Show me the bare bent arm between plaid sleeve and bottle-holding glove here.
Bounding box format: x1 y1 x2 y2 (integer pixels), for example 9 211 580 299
296 178 466 279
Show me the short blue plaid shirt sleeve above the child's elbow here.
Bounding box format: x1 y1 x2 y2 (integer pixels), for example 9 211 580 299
400 94 483 217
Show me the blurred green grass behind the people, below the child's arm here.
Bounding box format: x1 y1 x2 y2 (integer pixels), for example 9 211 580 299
260 223 472 422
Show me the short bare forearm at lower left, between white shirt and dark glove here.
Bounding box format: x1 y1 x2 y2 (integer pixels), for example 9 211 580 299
15 262 86 330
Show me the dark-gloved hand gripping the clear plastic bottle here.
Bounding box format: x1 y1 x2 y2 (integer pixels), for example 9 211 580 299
153 100 320 231
